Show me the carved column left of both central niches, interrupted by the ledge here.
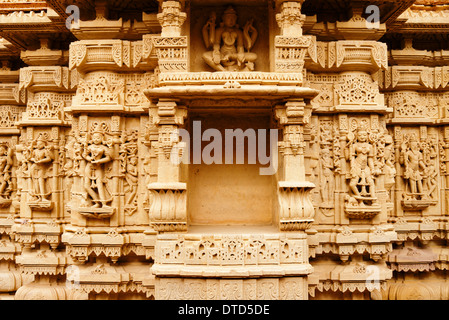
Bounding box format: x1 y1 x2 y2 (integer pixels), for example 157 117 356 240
148 1 188 232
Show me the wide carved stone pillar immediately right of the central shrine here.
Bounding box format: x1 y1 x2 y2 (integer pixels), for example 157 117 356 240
305 2 396 298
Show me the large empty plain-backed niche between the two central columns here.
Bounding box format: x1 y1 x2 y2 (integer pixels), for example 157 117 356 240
187 112 277 226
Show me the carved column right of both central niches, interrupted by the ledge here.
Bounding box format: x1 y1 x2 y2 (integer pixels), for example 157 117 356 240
275 1 315 231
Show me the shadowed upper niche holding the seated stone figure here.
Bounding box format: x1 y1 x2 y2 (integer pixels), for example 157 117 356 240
189 0 270 72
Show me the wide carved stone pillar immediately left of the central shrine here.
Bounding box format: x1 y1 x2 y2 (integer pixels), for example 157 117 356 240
58 1 157 299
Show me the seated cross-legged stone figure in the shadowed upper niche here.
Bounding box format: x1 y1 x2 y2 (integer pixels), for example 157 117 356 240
203 7 257 71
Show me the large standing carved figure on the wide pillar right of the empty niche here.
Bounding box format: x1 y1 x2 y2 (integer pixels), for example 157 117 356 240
349 128 377 202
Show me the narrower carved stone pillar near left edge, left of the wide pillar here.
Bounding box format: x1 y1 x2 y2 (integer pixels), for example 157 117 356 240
13 39 74 299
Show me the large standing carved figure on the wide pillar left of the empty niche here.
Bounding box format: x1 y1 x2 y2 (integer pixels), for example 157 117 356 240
82 131 112 208
